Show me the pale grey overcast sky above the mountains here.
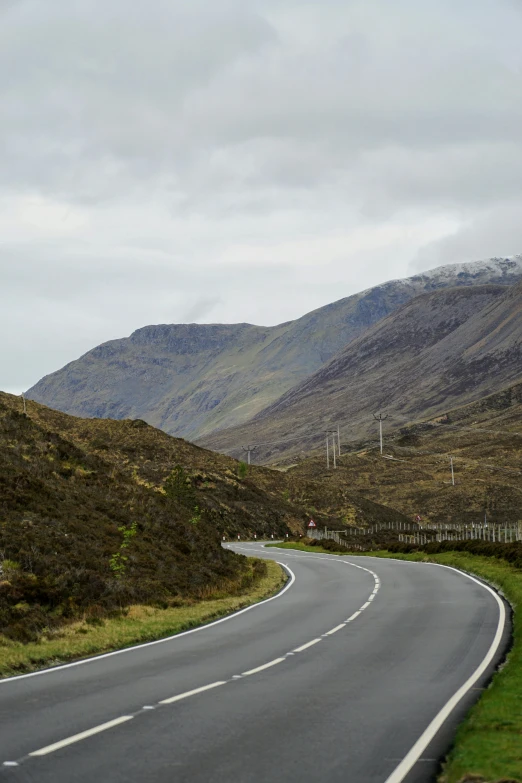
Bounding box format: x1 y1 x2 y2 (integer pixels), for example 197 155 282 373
0 0 522 392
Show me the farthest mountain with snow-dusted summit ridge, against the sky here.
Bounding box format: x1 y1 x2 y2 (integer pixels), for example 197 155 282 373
27 256 522 440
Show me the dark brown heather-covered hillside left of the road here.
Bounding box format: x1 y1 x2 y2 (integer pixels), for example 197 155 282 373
0 393 406 641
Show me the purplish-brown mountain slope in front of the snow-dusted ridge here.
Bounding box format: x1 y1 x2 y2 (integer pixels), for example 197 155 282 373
200 283 522 461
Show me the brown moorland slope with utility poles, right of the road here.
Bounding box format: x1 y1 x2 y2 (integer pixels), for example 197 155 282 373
286 383 522 525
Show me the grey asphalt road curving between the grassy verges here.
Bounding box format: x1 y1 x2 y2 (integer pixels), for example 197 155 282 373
0 544 509 783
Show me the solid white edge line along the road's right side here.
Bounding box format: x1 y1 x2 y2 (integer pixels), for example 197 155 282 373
385 561 506 783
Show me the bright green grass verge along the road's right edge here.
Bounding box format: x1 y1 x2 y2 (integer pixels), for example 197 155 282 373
268 542 522 783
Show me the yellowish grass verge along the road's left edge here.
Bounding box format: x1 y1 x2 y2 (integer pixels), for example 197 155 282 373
0 560 287 677
